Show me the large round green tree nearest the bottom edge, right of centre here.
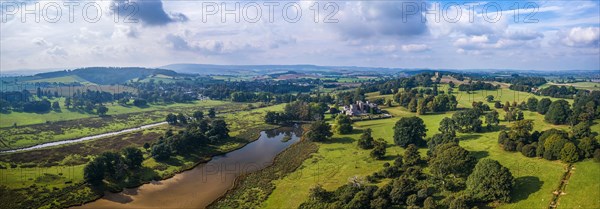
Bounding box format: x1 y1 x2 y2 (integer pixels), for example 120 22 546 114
467 159 514 202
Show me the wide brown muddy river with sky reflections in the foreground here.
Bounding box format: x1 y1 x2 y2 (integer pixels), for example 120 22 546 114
76 127 301 208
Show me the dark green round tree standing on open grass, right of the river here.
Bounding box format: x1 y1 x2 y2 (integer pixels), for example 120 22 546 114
394 116 427 148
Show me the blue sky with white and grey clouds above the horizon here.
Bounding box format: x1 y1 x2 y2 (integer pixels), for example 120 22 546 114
0 0 600 71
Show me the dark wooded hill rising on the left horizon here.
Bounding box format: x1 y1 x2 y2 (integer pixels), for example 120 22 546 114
35 67 178 85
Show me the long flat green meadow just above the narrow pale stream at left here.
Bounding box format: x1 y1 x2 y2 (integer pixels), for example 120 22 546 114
0 101 246 150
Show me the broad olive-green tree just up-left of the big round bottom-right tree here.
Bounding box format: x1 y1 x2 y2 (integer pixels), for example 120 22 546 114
430 143 477 177
